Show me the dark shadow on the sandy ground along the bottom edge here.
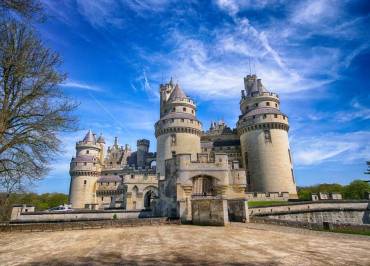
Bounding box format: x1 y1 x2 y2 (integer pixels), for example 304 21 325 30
27 252 278 266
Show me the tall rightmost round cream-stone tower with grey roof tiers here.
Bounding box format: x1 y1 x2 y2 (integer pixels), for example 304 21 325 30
237 75 297 198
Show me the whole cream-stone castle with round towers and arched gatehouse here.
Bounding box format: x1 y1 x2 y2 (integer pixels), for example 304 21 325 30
70 75 297 220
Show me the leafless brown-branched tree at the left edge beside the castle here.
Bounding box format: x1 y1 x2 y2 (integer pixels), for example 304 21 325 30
0 21 76 193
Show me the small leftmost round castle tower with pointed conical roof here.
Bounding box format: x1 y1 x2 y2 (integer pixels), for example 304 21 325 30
69 130 102 208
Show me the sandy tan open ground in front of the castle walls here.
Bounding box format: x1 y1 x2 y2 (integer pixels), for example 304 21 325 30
0 224 370 266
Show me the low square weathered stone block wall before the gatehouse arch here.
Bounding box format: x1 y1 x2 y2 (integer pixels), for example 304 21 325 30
191 198 229 226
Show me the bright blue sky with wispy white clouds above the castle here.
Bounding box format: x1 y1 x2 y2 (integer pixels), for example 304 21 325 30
31 0 370 193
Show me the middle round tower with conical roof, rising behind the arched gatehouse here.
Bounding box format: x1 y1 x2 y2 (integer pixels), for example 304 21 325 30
155 79 202 179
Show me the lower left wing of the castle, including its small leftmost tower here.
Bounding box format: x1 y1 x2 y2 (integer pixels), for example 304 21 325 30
69 131 158 210
